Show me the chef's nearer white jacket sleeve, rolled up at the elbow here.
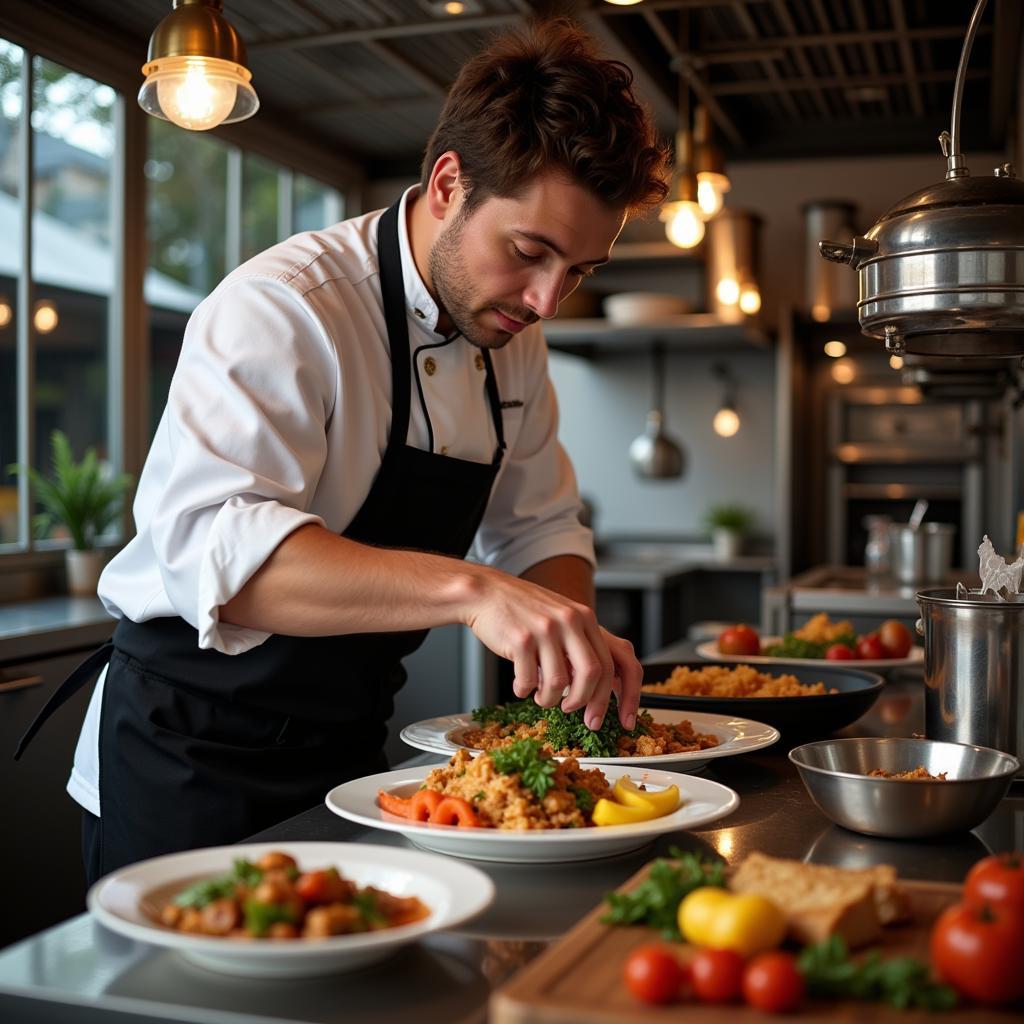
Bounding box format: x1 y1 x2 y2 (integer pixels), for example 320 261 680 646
151 278 337 654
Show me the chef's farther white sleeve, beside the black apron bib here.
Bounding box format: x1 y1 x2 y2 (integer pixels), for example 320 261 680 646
472 334 596 575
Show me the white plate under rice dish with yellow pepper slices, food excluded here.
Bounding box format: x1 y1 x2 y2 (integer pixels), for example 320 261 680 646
326 765 739 863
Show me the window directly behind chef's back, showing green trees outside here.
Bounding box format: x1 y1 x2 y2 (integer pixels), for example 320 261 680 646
145 128 344 438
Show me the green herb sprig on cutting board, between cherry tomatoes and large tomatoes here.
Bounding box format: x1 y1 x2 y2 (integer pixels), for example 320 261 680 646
798 935 956 1010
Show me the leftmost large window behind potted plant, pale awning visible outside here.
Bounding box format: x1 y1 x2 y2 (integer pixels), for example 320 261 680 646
0 40 118 548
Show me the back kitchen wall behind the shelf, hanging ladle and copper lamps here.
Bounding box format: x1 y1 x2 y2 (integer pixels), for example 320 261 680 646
365 144 1007 539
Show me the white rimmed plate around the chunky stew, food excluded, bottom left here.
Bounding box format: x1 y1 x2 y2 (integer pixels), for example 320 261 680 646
86 843 495 978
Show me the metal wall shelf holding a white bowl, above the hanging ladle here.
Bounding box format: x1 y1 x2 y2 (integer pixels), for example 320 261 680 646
544 313 770 356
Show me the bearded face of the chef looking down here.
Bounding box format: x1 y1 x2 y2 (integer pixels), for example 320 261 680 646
429 174 625 348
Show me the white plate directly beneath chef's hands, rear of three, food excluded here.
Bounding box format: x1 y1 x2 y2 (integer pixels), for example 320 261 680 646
401 709 779 771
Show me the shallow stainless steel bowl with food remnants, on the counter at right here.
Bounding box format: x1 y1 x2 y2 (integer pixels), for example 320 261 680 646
790 736 1020 839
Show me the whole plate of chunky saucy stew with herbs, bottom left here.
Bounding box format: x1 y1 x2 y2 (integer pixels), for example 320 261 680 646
86 843 494 977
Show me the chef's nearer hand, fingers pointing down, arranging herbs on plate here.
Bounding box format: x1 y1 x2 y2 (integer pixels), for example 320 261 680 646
466 572 643 729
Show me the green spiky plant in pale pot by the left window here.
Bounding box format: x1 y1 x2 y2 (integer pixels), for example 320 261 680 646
9 430 132 595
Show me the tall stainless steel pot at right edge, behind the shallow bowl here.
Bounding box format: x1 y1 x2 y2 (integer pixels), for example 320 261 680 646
918 588 1024 774
